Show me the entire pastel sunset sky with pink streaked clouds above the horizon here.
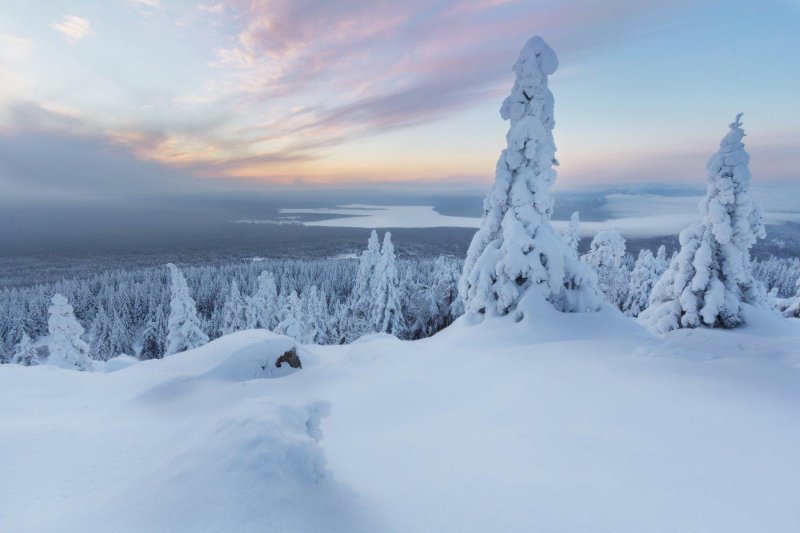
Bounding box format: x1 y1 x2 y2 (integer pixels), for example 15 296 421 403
0 0 800 201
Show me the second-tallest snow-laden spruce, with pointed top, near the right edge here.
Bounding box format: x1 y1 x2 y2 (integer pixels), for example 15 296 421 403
641 113 768 332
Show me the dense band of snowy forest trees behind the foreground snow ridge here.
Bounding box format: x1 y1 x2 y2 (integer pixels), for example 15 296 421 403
0 223 800 368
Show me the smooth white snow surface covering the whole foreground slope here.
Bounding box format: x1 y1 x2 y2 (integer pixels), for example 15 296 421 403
0 307 800 533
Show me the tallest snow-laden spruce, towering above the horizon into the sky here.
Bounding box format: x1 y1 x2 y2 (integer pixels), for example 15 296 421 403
459 37 602 318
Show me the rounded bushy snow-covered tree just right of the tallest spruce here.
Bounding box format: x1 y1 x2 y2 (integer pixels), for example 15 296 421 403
581 230 628 308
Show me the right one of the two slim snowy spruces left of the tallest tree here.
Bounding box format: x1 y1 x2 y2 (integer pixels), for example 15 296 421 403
371 231 405 337
